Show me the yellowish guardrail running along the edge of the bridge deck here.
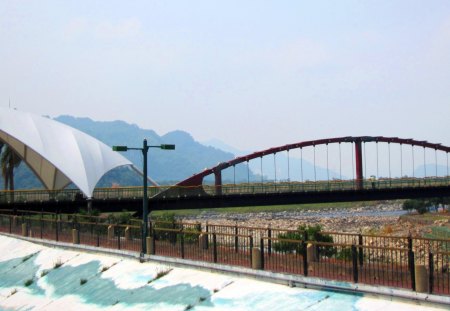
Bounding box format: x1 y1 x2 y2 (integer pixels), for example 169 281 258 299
0 176 450 204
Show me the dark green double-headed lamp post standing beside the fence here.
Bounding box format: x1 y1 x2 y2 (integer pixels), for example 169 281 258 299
112 139 175 254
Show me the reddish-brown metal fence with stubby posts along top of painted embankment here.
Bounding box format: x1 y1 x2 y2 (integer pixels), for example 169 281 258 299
0 214 450 295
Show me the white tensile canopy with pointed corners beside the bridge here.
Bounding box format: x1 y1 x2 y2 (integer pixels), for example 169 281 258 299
0 107 132 198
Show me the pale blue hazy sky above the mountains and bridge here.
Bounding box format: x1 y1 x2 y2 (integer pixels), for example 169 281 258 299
0 0 450 150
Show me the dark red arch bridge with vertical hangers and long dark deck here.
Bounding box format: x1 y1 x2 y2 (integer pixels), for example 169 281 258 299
0 136 450 214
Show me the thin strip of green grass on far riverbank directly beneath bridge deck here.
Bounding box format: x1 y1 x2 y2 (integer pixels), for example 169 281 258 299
152 201 379 217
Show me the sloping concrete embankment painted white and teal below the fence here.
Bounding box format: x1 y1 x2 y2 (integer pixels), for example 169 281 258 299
0 235 446 311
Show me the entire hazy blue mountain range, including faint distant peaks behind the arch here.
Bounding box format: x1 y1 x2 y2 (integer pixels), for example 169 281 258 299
0 115 446 189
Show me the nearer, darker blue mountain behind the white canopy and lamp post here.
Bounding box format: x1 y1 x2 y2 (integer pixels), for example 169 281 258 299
0 115 255 189
